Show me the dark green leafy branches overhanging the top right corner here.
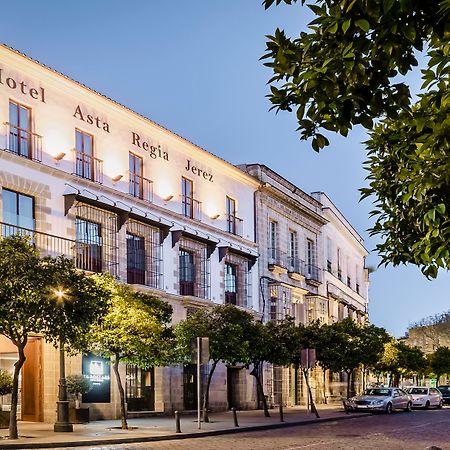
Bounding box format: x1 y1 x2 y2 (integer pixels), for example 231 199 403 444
263 0 450 277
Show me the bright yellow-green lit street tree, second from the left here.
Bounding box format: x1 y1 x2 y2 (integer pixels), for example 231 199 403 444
89 276 176 429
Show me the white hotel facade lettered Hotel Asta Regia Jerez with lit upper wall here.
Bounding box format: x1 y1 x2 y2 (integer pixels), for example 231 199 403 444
0 46 259 422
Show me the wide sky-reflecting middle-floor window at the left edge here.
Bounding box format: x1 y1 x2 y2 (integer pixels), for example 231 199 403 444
3 189 35 232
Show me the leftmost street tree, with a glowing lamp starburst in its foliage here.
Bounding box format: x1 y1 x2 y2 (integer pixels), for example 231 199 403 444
0 236 109 439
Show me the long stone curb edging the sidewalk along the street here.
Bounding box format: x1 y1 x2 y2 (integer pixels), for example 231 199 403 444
0 413 368 450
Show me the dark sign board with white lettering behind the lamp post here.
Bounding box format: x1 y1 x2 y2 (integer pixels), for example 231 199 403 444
82 353 111 403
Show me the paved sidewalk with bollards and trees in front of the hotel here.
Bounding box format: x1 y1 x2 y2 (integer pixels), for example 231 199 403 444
0 405 367 450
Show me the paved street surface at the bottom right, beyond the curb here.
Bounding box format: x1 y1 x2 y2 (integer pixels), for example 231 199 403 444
36 408 450 450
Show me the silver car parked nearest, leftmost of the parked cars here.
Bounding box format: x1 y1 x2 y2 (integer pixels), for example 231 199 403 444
346 387 413 414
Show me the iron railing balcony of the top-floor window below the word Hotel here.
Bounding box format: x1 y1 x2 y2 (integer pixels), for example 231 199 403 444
5 122 42 162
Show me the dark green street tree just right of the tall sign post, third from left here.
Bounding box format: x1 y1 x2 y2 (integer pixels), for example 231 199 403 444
175 305 253 422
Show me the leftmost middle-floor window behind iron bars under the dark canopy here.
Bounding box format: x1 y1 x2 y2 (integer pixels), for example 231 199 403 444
75 217 102 272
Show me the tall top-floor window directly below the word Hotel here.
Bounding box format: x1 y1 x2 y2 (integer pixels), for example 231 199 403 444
9 101 32 158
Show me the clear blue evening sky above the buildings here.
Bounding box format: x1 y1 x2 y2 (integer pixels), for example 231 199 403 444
0 0 450 337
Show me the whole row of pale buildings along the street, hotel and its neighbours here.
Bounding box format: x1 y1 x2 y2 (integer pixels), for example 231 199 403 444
0 45 368 422
